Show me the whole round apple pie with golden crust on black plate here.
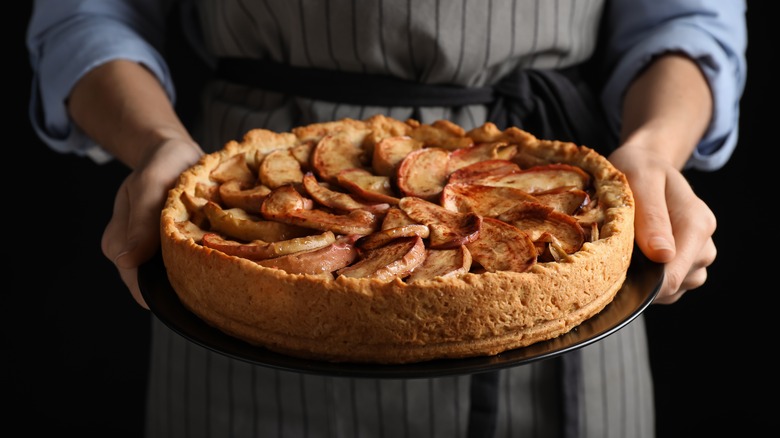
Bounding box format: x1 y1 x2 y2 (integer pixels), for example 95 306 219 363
161 116 634 364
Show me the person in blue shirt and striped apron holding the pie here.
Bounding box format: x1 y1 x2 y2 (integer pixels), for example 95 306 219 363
28 0 746 437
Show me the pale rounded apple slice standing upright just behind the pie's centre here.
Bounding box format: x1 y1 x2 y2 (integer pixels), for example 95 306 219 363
396 147 450 202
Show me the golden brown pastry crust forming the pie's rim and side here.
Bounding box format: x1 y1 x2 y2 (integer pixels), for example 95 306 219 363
161 117 634 364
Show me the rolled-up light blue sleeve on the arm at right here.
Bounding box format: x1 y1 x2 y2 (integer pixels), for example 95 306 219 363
602 0 747 171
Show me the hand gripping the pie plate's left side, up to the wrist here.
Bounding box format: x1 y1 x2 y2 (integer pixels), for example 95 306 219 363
101 138 203 309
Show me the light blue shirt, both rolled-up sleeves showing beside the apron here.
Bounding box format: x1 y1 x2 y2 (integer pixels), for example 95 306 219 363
27 0 747 170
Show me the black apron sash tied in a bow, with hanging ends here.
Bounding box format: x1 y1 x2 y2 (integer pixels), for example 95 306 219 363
216 58 616 438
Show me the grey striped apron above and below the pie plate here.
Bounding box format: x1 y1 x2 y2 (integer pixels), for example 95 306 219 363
147 0 654 438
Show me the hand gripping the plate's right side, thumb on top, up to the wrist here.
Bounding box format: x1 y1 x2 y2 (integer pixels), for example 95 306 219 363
609 147 717 304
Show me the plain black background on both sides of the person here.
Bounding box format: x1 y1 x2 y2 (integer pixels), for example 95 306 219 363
0 1 778 437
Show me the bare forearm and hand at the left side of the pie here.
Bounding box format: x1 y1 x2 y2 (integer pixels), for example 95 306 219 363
68 60 203 309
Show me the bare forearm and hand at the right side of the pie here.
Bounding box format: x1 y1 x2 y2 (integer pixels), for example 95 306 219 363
609 53 717 304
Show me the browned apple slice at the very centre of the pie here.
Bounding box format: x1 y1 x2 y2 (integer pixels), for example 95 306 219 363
398 196 482 249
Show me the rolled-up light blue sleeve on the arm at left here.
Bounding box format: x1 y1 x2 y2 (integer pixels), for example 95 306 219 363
27 0 175 163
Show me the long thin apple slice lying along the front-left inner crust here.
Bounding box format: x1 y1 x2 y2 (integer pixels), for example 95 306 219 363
201 231 336 261
